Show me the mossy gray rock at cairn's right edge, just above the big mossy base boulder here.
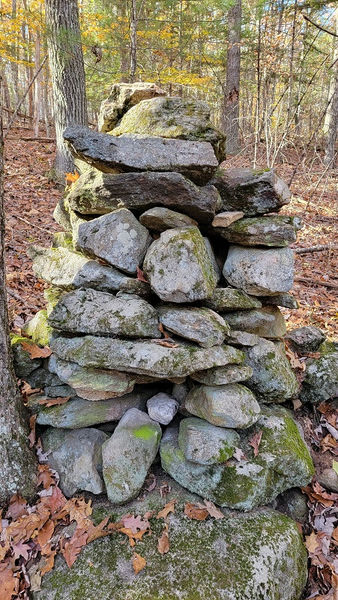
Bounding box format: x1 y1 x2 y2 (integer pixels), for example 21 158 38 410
243 338 299 403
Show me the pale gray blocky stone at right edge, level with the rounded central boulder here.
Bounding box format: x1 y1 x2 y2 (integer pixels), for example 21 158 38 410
223 246 294 296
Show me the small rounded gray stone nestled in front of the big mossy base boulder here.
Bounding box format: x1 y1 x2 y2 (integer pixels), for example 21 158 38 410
178 417 240 465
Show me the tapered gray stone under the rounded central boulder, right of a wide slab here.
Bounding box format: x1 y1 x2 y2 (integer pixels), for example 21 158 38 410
158 306 230 348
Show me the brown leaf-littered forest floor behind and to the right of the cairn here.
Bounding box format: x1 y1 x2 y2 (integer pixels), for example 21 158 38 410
5 128 338 600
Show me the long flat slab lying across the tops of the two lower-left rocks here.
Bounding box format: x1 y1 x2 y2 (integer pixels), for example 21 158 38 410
36 387 154 429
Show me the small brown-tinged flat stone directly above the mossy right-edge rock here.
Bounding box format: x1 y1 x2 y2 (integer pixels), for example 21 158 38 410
224 306 286 339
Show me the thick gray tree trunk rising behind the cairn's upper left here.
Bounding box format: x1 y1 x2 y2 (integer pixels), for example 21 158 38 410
46 0 88 182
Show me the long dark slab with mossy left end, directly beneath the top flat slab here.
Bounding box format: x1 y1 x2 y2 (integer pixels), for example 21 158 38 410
67 169 222 223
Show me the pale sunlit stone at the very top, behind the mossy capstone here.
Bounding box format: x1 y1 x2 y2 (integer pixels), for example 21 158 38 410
98 81 166 132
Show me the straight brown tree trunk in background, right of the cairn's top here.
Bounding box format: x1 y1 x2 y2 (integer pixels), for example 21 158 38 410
222 0 242 154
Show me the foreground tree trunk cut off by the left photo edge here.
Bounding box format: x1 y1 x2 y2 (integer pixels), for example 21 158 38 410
0 102 36 503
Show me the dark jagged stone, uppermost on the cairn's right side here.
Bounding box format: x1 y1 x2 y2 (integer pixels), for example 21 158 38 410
212 168 291 217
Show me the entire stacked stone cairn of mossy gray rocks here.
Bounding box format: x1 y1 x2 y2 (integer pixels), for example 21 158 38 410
14 83 320 510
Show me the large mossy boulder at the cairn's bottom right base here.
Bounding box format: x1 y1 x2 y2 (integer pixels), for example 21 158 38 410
160 407 314 510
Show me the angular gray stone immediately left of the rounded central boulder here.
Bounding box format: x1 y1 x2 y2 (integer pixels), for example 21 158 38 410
74 208 151 275
